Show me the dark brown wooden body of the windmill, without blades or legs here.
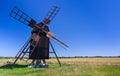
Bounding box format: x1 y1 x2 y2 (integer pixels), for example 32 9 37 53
29 23 49 59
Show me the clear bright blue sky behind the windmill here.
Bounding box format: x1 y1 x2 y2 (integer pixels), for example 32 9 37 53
0 0 120 56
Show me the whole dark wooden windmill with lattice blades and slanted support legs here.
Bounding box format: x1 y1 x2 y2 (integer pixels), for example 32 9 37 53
10 6 69 67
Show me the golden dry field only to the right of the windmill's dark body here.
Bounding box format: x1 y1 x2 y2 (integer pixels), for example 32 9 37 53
48 58 120 65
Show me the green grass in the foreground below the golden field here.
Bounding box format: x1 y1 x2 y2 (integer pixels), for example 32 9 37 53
0 64 120 76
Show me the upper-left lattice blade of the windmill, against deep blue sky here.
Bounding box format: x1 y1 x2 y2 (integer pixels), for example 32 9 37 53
10 6 36 27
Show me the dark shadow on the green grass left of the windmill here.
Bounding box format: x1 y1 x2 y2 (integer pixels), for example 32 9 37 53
0 64 28 69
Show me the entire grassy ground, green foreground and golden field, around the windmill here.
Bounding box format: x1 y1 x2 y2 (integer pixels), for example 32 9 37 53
0 58 120 76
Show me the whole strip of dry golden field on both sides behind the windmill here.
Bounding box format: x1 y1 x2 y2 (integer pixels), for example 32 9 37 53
0 58 120 66
